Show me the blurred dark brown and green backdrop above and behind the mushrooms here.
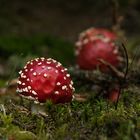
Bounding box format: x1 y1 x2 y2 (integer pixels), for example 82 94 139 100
0 0 140 77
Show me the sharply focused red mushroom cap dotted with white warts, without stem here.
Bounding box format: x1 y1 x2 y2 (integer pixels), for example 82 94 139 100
17 58 74 103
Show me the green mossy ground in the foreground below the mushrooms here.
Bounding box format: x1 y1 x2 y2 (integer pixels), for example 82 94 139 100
0 88 140 140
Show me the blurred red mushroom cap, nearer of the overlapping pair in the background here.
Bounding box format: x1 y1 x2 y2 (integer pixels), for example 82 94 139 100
77 39 121 72
